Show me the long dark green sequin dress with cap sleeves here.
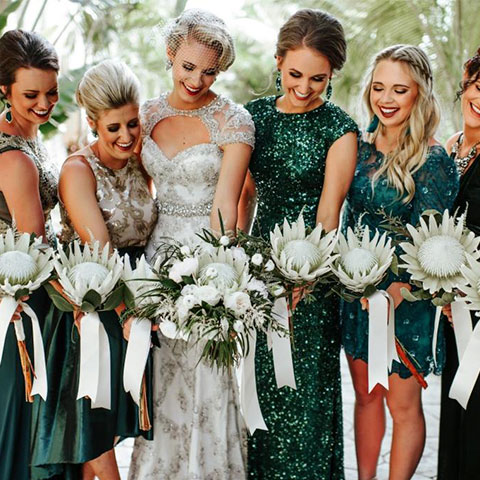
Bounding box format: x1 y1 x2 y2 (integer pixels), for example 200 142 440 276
246 97 357 480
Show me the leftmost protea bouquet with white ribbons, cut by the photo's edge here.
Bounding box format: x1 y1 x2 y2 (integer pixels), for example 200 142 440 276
0 229 53 402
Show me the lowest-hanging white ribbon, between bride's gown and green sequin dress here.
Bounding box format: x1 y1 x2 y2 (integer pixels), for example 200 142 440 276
236 330 268 435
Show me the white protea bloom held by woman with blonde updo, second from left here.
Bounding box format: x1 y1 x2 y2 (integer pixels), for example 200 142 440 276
54 240 123 306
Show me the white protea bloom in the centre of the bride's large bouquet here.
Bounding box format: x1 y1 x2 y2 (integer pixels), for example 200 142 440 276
197 247 249 292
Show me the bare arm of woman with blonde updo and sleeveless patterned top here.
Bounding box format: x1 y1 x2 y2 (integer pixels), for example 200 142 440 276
58 156 110 246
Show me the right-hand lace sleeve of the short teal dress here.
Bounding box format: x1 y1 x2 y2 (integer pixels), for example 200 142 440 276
410 146 459 225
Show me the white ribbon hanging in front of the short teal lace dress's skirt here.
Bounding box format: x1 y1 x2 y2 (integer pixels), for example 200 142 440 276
368 290 400 393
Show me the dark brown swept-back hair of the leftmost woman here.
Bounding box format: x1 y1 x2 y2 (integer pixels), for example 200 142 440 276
0 30 59 97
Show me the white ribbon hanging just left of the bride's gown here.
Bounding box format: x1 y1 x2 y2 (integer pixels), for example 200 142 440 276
123 318 152 406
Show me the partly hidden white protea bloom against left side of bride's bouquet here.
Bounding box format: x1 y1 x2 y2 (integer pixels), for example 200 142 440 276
122 255 161 307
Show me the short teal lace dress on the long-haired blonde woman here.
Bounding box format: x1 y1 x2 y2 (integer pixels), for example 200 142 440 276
341 141 458 378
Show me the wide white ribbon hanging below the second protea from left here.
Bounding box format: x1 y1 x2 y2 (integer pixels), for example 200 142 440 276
77 312 111 409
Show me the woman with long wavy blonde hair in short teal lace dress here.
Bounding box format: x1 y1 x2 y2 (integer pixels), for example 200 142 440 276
342 45 458 480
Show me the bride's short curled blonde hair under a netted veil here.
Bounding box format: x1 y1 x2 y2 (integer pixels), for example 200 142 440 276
164 9 235 71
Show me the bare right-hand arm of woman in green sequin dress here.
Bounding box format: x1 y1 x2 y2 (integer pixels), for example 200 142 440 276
317 132 357 231
